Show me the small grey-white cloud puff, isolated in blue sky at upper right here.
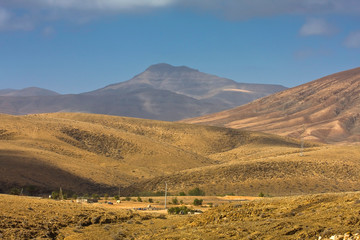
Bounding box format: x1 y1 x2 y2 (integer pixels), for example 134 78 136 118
299 18 335 36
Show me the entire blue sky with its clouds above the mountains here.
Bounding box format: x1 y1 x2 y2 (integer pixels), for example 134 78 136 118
0 0 360 93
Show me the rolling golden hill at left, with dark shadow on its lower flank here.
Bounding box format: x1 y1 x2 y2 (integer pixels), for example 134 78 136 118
0 113 304 191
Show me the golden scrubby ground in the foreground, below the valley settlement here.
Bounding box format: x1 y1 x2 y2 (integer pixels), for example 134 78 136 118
0 192 360 240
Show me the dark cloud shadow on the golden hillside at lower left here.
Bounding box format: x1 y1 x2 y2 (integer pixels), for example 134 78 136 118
0 150 122 194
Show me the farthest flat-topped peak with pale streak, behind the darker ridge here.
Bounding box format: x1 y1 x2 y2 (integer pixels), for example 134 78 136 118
90 63 286 109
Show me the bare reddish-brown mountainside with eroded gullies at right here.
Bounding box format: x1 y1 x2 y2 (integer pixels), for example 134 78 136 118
185 68 360 143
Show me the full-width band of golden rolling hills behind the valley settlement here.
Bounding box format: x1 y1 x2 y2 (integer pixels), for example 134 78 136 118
0 113 360 195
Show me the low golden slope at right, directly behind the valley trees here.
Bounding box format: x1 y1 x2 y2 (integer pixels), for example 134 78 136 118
131 145 360 196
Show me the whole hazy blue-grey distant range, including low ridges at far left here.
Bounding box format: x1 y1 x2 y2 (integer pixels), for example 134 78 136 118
0 64 285 121
